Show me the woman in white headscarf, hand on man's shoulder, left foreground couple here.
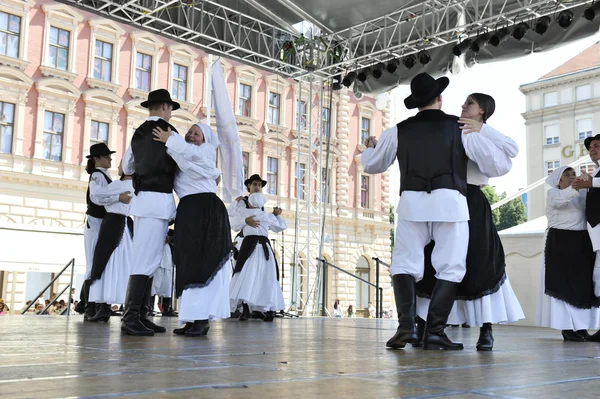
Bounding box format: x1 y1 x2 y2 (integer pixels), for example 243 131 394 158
154 123 232 337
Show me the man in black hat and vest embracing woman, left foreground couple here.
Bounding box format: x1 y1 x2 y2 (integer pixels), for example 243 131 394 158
121 89 179 335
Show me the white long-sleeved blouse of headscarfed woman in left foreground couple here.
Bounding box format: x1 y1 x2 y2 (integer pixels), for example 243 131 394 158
166 134 221 198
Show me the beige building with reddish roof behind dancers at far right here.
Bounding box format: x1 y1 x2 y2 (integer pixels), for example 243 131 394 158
520 43 600 220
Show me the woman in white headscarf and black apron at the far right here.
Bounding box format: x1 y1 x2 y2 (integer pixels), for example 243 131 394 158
536 166 600 342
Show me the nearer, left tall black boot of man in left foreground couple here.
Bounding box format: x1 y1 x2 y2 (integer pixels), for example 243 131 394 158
121 274 154 336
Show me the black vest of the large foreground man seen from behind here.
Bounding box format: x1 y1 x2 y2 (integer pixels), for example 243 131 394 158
397 110 468 196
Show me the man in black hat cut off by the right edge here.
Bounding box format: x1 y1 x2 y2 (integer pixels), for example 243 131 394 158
572 134 600 342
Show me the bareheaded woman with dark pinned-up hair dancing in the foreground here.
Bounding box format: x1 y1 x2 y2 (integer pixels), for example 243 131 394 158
417 93 525 351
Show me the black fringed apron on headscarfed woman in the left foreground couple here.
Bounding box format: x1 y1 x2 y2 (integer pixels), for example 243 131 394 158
173 193 233 297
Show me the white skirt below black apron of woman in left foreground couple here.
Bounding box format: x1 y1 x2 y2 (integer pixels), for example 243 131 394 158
179 262 231 324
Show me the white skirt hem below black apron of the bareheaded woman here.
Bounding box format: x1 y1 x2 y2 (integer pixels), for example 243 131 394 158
417 276 525 327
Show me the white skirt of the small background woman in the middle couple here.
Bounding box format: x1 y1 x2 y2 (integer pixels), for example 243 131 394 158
229 245 285 312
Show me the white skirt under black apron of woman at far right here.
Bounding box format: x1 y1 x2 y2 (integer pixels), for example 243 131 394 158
536 255 600 331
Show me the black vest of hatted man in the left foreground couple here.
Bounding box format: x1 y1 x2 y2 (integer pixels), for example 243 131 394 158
131 119 177 194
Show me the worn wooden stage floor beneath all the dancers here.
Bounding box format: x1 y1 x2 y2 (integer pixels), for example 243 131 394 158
0 316 600 399
